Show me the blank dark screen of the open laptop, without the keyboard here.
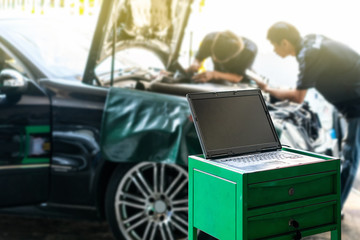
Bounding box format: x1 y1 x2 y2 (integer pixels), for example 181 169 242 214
188 90 280 157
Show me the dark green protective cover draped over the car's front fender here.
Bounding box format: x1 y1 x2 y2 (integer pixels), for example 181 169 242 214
101 88 201 165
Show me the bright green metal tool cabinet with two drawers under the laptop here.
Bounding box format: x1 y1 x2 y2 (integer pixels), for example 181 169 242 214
189 148 341 240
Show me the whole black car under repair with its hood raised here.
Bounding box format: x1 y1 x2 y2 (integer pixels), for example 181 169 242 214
0 0 338 240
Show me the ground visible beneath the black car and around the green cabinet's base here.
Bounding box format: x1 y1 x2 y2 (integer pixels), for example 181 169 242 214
0 171 360 240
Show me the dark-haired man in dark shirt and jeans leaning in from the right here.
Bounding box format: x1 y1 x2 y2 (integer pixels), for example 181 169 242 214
254 22 360 208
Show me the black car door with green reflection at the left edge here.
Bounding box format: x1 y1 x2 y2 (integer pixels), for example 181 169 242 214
0 43 51 207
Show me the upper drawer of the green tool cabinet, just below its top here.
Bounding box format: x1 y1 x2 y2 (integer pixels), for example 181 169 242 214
247 171 336 209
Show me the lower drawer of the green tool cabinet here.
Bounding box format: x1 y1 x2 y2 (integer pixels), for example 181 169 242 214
247 201 336 239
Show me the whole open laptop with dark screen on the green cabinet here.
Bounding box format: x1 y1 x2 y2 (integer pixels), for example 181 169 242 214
186 89 321 171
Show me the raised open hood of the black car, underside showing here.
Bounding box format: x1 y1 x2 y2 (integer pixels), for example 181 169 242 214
84 0 192 82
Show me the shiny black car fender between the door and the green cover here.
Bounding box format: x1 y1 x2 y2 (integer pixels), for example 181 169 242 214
39 79 108 206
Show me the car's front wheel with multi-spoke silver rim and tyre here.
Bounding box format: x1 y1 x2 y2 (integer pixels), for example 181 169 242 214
105 162 188 240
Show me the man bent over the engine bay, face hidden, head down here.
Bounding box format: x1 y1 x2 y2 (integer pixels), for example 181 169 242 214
187 31 257 83
